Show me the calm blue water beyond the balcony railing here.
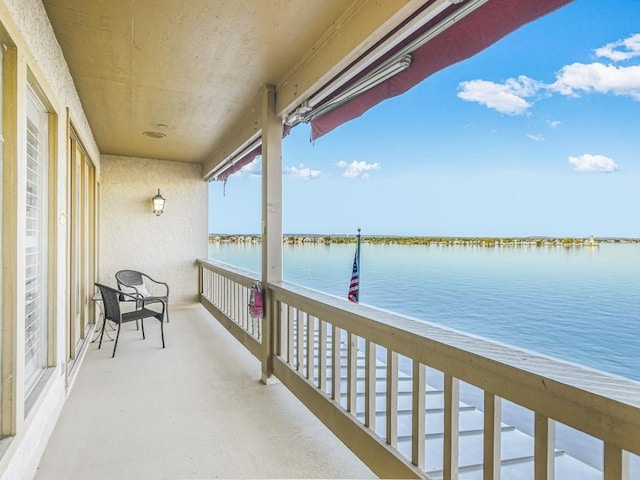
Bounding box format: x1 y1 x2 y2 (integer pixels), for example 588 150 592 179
209 244 640 380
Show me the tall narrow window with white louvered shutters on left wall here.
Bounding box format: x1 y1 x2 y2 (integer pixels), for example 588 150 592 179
25 86 49 395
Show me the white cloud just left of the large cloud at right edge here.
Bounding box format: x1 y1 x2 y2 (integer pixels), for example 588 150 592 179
458 75 542 115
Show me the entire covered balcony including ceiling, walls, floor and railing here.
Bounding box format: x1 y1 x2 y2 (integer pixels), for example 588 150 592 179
0 0 640 480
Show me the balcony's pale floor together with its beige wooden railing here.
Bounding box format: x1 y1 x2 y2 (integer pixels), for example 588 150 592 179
37 260 640 480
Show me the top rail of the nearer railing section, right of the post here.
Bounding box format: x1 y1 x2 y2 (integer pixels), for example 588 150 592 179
268 282 640 454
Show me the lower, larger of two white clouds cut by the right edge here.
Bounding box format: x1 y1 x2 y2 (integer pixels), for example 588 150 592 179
549 63 640 101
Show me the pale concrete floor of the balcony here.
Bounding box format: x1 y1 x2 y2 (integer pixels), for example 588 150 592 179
36 305 374 480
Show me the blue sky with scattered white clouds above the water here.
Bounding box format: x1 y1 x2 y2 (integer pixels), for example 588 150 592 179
209 0 640 237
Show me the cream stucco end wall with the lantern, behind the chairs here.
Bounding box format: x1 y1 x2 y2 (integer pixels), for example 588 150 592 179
99 156 207 305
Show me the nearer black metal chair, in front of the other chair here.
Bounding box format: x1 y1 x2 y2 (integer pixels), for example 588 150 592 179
96 283 166 358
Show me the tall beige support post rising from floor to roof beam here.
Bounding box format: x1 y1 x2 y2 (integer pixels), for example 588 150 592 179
261 81 282 384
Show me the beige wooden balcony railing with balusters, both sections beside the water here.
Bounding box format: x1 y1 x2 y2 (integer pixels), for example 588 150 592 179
198 260 640 480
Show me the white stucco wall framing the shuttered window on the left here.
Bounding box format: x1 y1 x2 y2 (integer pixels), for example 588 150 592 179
0 0 100 480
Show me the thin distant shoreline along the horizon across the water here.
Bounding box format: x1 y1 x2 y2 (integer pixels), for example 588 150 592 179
209 234 640 247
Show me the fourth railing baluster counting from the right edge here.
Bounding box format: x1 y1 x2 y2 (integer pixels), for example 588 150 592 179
443 373 460 480
